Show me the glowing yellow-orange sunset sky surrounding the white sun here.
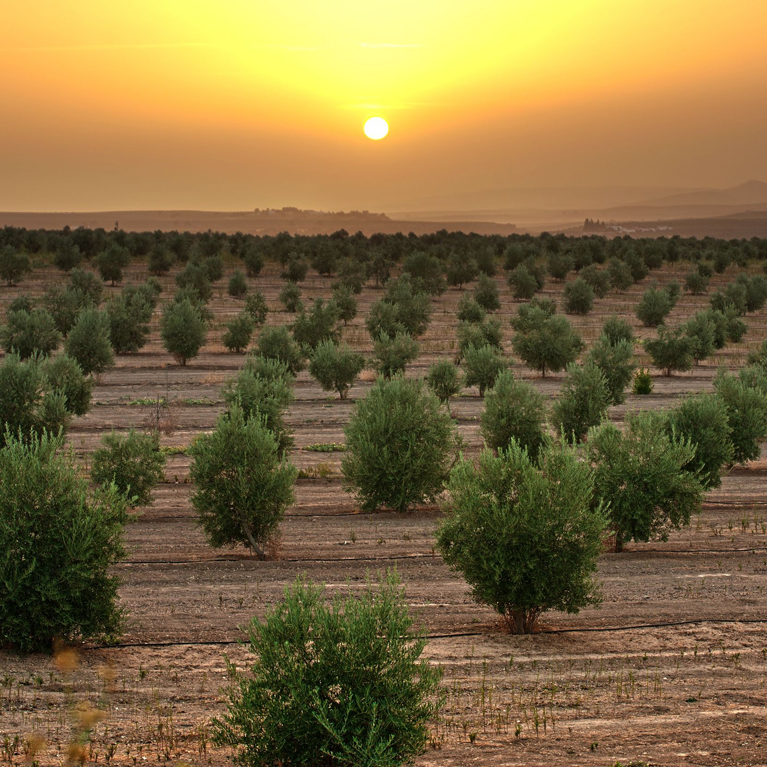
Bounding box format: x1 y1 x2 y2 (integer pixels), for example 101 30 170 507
0 0 767 211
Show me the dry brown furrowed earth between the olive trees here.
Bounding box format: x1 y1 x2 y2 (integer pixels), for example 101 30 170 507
0 265 767 767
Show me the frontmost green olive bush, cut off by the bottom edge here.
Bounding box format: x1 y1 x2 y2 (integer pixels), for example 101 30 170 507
213 575 443 767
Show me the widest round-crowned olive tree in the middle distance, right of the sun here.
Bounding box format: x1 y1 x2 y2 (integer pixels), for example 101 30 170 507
511 303 583 378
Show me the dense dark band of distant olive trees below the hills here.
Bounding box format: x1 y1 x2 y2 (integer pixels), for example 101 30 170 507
0 227 767 284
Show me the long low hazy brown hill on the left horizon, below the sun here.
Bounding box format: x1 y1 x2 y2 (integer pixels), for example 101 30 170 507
0 208 517 236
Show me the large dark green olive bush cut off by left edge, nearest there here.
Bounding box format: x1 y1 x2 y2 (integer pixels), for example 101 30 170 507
0 433 127 652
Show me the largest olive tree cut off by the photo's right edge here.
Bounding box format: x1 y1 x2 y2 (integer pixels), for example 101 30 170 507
714 370 767 463
